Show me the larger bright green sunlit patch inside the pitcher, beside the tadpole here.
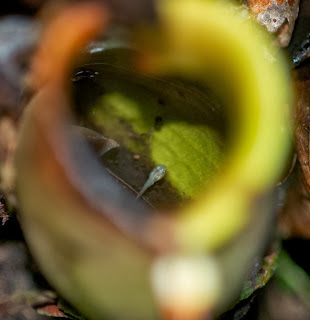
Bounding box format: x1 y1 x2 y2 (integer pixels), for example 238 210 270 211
151 122 222 198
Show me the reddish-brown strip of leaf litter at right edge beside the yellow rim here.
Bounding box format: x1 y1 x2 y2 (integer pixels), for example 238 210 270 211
279 63 310 238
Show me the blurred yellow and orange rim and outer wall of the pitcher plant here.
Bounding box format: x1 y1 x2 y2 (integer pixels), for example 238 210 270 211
16 0 292 319
